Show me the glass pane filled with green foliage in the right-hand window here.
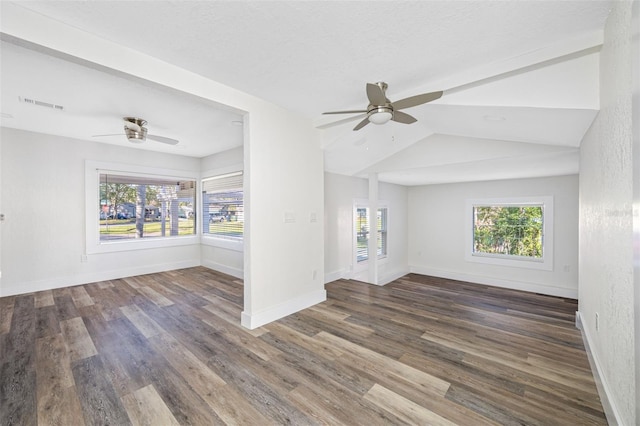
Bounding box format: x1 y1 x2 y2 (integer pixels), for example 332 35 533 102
473 205 544 259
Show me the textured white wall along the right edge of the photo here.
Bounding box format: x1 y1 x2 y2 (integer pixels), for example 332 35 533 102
579 2 640 425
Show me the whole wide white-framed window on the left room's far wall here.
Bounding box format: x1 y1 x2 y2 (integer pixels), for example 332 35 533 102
84 160 200 254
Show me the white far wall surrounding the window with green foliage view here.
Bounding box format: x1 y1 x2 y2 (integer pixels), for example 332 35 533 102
408 175 578 298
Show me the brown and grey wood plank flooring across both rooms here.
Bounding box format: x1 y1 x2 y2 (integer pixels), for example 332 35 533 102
0 267 606 426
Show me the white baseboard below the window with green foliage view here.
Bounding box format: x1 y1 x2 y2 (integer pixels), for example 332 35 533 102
409 266 578 299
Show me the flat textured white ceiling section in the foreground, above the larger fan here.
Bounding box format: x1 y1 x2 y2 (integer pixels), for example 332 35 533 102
8 1 608 117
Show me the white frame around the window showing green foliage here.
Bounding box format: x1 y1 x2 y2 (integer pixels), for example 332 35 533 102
465 196 554 271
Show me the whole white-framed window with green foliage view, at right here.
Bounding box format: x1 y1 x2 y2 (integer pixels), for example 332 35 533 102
466 197 553 270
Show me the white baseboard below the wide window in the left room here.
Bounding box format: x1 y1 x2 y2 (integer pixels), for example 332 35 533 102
0 261 200 297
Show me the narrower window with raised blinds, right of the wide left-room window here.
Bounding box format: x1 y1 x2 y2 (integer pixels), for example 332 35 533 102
202 172 244 240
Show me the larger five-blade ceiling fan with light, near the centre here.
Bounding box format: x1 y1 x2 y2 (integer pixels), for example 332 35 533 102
323 81 442 130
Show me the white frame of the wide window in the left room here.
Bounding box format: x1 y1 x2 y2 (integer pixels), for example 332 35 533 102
85 160 200 254
